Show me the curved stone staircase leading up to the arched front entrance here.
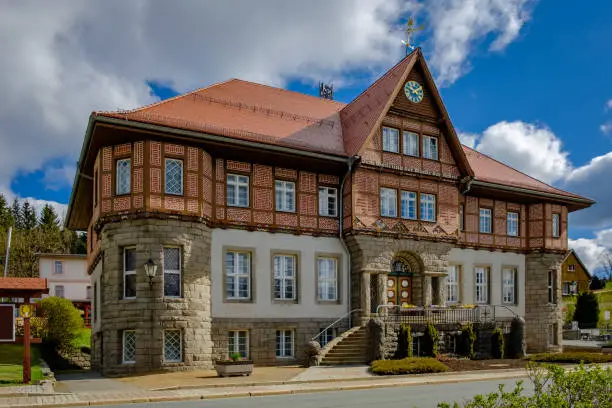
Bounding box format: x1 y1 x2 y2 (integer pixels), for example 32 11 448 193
321 327 368 365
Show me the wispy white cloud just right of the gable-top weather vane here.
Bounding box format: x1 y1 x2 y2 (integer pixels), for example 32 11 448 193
425 0 535 85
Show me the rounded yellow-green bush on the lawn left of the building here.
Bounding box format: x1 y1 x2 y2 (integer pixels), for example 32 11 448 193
39 297 83 351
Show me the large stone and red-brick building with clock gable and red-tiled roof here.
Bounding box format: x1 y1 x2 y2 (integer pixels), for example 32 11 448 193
66 49 593 374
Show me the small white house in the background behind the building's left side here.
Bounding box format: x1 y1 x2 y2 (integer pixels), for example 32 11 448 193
38 254 91 325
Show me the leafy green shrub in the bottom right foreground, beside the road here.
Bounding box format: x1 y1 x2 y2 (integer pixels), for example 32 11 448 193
438 364 612 408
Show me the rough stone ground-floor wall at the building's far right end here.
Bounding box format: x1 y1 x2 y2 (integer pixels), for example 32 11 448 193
525 253 564 353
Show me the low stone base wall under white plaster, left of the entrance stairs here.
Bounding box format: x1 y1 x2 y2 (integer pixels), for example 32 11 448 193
212 318 348 365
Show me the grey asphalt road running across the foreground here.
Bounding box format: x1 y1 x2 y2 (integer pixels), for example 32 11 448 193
74 379 533 408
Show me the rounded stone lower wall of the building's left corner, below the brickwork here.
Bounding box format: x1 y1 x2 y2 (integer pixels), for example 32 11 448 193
92 219 212 375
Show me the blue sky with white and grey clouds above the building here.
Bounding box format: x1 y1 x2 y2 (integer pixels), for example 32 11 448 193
0 0 612 270
